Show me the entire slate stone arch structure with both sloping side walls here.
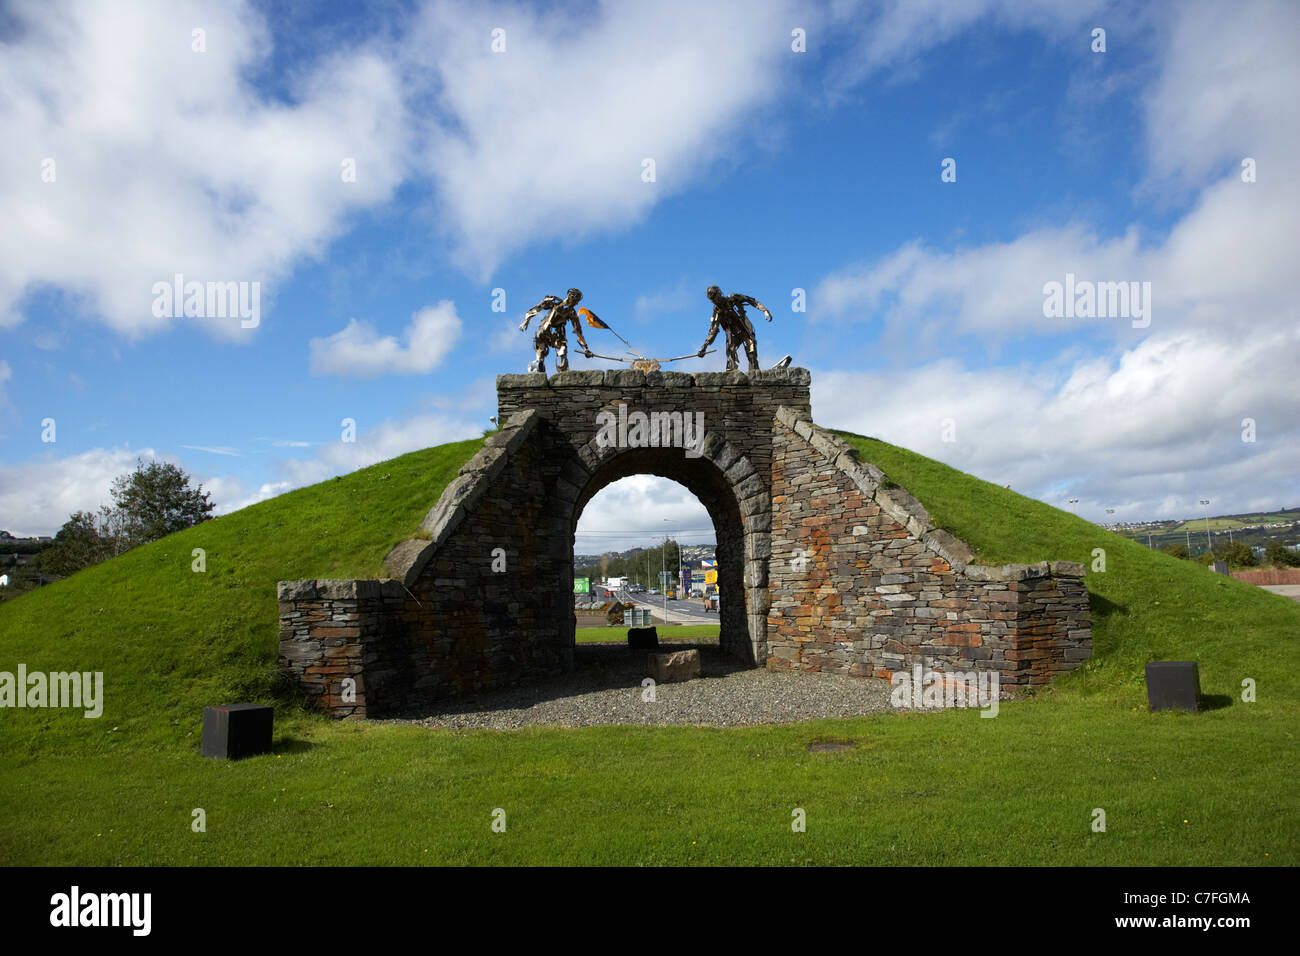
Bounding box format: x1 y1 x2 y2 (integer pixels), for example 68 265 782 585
280 368 1091 717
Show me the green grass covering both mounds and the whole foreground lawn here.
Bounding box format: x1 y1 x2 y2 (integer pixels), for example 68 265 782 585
0 436 1300 865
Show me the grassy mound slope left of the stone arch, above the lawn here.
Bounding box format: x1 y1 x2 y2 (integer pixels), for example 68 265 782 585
0 440 482 753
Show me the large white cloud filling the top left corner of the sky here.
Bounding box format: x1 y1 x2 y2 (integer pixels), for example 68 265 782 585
0 0 406 337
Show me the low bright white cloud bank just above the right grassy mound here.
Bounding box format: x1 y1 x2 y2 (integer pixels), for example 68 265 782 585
813 326 1300 520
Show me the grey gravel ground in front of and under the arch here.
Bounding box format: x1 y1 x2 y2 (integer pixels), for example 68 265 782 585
382 643 892 730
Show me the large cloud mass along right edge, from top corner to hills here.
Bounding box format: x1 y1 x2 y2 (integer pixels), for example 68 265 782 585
810 4 1300 520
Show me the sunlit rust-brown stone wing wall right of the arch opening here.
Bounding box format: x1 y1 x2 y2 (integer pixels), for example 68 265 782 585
767 408 1092 684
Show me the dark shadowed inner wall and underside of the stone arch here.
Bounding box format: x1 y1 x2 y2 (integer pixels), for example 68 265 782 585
567 447 757 663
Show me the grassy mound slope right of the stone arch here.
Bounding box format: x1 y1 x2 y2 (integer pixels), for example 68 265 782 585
837 432 1300 701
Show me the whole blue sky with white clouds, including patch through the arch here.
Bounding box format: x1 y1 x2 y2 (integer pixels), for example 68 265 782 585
0 0 1300 550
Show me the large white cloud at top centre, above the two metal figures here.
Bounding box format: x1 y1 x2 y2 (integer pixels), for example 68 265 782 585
406 0 792 276
